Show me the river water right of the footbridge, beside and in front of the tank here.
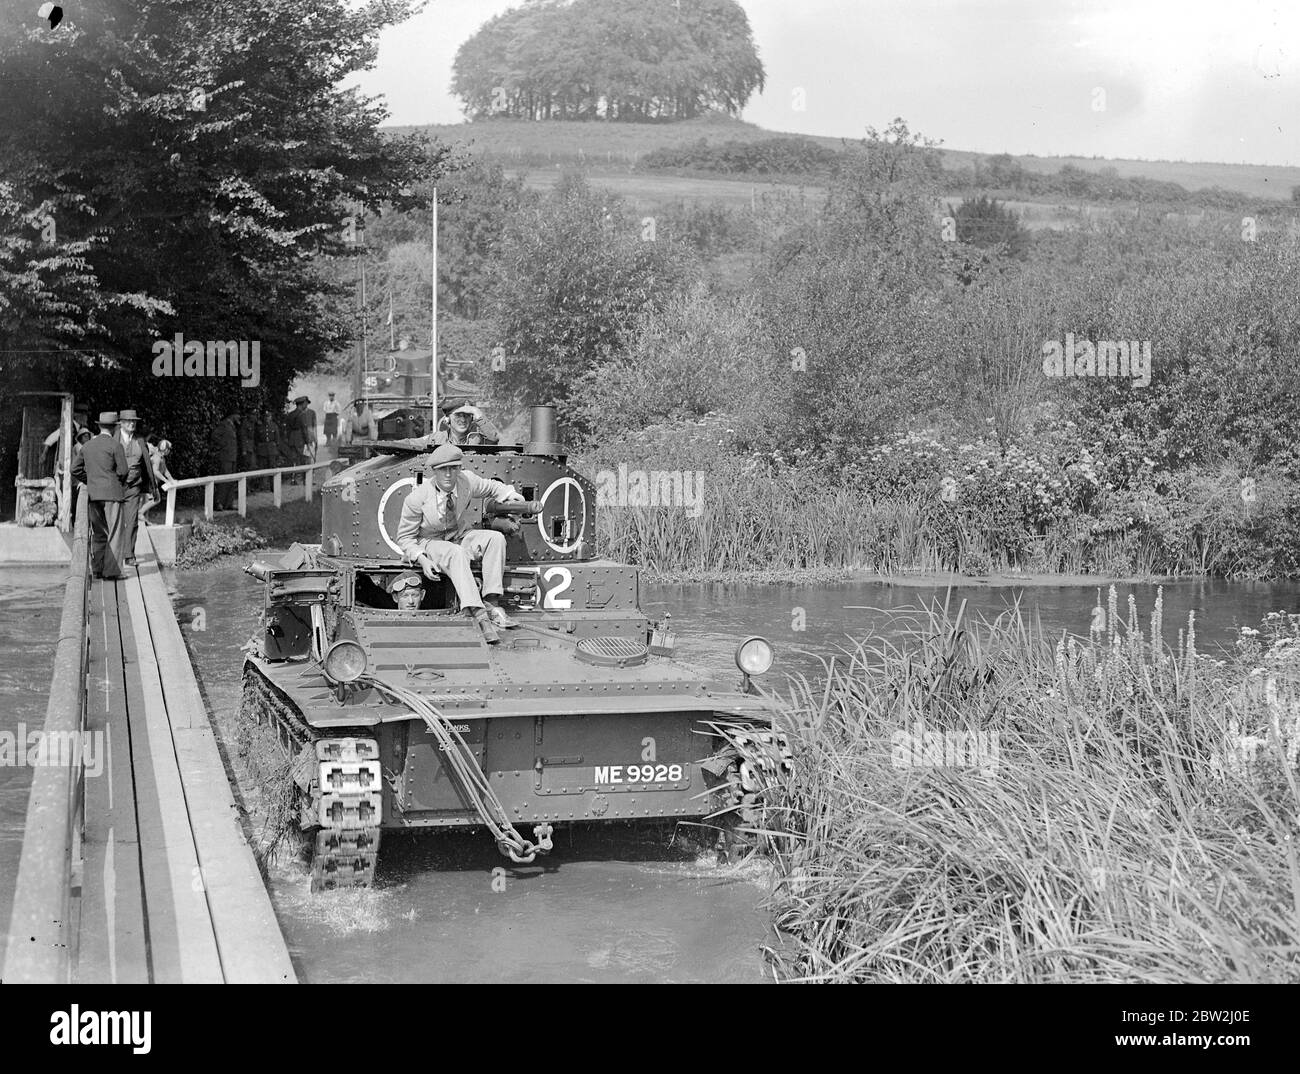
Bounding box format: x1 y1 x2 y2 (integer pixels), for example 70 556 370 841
170 568 775 983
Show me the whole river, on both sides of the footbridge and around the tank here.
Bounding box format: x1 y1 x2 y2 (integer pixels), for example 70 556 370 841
0 567 1300 982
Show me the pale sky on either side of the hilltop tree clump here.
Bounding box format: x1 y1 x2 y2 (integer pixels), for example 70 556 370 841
345 0 1300 165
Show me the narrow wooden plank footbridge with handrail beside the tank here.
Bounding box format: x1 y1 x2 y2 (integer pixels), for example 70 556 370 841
3 489 295 983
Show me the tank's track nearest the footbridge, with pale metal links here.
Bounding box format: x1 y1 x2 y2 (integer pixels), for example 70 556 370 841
242 663 384 892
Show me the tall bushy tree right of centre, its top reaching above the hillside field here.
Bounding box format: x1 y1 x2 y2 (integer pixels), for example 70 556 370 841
742 120 948 462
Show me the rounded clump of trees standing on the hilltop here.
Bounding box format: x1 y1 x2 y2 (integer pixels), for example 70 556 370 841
451 0 763 122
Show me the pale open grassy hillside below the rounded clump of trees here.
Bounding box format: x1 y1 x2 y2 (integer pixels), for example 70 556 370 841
391 114 1300 202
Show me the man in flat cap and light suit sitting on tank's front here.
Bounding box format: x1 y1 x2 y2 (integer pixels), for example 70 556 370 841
397 443 524 645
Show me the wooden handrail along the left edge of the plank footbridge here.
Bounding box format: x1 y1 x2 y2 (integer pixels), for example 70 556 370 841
4 485 90 984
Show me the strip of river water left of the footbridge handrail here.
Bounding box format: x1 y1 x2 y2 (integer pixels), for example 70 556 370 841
0 567 74 960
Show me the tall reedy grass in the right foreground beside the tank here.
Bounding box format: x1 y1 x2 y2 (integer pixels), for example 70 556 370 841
768 589 1300 982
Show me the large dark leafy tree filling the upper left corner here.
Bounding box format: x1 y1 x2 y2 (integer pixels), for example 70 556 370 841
0 0 449 472
